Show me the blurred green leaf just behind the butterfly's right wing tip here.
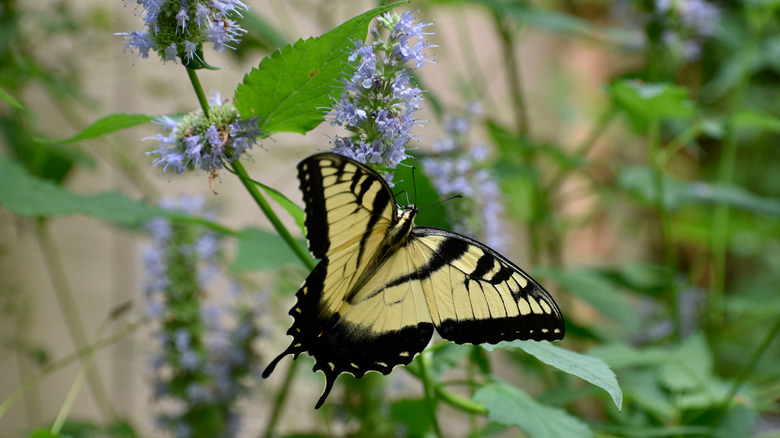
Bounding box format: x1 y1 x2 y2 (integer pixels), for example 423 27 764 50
537 268 639 329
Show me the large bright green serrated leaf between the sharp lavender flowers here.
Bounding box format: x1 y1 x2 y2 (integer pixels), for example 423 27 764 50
235 2 405 136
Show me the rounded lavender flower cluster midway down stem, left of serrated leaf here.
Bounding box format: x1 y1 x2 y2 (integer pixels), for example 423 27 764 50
145 93 260 175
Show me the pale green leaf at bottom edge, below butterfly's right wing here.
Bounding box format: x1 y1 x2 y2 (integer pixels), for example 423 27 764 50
474 383 593 438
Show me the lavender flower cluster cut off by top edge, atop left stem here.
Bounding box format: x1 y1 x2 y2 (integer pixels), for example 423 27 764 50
116 0 249 65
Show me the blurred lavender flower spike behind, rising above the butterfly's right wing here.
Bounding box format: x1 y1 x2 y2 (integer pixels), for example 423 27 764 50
422 105 506 251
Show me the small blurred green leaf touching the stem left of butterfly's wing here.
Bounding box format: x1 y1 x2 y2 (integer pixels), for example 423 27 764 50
230 228 306 273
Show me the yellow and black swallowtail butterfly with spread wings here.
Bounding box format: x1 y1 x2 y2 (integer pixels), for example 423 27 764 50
263 153 564 408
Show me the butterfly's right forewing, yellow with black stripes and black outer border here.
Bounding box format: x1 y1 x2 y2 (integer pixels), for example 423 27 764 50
407 227 565 344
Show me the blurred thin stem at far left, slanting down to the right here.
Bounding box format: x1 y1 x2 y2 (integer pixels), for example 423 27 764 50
37 219 116 420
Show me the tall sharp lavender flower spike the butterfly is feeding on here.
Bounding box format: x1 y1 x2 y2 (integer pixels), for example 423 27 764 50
331 12 436 184
